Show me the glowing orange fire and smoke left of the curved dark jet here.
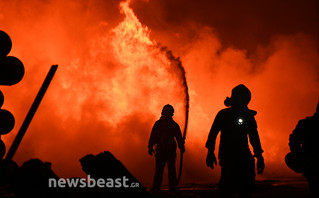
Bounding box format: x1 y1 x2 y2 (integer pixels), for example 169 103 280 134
3 1 189 186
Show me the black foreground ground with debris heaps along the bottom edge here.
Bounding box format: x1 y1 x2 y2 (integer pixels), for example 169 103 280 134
0 155 311 198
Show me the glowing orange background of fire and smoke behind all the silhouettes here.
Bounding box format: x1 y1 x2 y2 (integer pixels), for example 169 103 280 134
0 0 319 185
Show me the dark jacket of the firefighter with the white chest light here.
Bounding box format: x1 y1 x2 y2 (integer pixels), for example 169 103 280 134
206 107 263 160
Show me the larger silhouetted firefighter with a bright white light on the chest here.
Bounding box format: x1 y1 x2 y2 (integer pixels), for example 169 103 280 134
206 84 265 198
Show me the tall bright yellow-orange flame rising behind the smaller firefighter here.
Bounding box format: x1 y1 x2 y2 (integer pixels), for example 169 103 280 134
111 1 188 124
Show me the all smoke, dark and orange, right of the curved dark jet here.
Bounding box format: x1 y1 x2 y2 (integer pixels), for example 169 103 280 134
132 0 319 182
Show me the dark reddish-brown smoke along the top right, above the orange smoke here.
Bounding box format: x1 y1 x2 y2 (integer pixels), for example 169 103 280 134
132 0 319 56
